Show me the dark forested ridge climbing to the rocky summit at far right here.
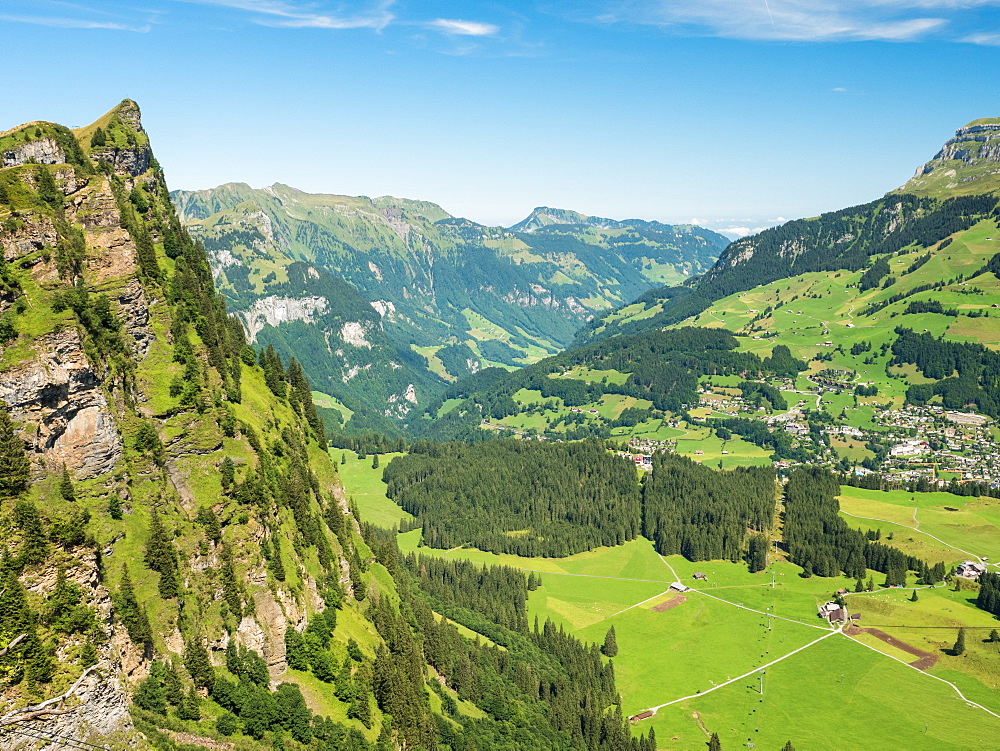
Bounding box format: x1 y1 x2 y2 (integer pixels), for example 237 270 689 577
578 119 1000 342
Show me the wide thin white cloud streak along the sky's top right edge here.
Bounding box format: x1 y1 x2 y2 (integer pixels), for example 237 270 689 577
568 0 1000 44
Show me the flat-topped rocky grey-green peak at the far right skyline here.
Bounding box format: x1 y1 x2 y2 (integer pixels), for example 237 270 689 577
900 117 1000 195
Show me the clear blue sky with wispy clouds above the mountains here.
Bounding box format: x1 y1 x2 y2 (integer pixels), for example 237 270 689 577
0 0 1000 235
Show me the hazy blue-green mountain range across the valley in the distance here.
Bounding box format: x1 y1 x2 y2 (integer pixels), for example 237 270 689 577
173 184 725 427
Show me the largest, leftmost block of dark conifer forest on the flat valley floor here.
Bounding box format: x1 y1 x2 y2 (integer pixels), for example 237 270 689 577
383 440 640 556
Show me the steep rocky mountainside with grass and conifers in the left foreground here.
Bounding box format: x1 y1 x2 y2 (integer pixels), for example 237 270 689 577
0 100 652 751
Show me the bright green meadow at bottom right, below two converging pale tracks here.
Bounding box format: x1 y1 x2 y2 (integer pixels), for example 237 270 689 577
648 636 1000 751
